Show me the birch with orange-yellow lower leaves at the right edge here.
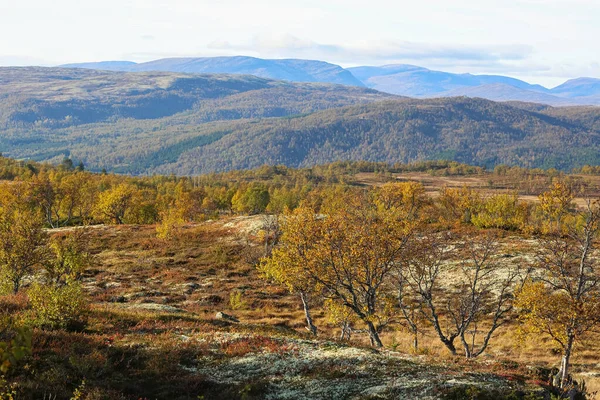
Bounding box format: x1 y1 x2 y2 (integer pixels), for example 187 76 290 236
517 199 600 388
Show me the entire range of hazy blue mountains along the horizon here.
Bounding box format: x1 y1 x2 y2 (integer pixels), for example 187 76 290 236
62 56 600 106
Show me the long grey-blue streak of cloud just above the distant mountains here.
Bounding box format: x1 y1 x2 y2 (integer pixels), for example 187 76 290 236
208 35 533 63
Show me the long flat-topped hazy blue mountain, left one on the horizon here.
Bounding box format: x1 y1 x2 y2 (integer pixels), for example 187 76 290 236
64 56 364 86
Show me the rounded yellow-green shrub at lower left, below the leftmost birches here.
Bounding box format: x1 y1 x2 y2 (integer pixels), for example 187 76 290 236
28 283 87 329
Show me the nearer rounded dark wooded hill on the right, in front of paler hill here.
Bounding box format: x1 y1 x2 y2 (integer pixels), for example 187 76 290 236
151 98 600 174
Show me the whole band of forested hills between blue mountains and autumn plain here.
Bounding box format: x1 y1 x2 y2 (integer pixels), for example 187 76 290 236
0 68 600 175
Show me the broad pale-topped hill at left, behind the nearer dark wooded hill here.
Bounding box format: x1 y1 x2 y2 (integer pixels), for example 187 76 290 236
0 67 393 129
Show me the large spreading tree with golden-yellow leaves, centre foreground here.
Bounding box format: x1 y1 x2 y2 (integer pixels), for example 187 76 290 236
261 182 425 347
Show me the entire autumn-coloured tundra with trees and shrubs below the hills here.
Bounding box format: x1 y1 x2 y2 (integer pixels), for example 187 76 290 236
0 158 600 399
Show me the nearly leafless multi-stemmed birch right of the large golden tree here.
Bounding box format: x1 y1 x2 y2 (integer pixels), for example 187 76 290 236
399 233 520 358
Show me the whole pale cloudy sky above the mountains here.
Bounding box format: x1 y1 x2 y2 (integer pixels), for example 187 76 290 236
0 0 600 87
